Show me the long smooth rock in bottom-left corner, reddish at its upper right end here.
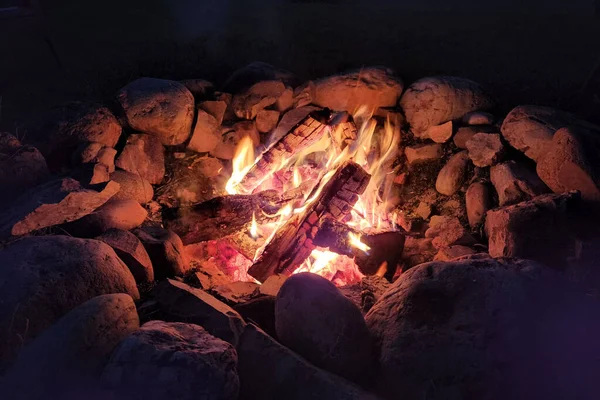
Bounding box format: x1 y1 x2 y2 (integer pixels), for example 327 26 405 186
3 293 140 400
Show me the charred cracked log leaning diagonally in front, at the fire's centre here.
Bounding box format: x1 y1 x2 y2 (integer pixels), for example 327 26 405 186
248 161 371 282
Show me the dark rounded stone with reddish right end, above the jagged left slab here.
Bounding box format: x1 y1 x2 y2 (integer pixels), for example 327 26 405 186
22 102 122 171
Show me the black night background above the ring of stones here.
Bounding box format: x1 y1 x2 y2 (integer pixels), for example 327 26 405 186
0 0 600 131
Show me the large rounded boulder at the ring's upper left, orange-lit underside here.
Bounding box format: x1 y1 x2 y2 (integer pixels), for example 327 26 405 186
117 78 194 145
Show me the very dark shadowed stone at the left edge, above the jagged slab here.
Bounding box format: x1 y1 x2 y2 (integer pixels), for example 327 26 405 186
0 132 50 205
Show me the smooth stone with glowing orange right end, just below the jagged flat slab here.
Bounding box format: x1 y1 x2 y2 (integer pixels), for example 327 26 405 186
61 199 148 238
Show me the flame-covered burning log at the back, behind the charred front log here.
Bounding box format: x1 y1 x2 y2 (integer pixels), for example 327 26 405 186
238 111 329 191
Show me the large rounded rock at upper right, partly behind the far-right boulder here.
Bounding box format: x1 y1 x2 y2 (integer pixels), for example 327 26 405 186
502 105 600 161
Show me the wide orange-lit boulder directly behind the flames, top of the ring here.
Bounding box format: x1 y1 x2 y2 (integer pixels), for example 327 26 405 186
307 67 404 113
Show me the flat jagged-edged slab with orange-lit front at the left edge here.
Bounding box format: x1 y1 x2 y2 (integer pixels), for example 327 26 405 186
0 178 119 237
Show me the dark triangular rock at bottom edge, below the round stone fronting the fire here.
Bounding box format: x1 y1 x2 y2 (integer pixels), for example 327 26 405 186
237 325 377 400
